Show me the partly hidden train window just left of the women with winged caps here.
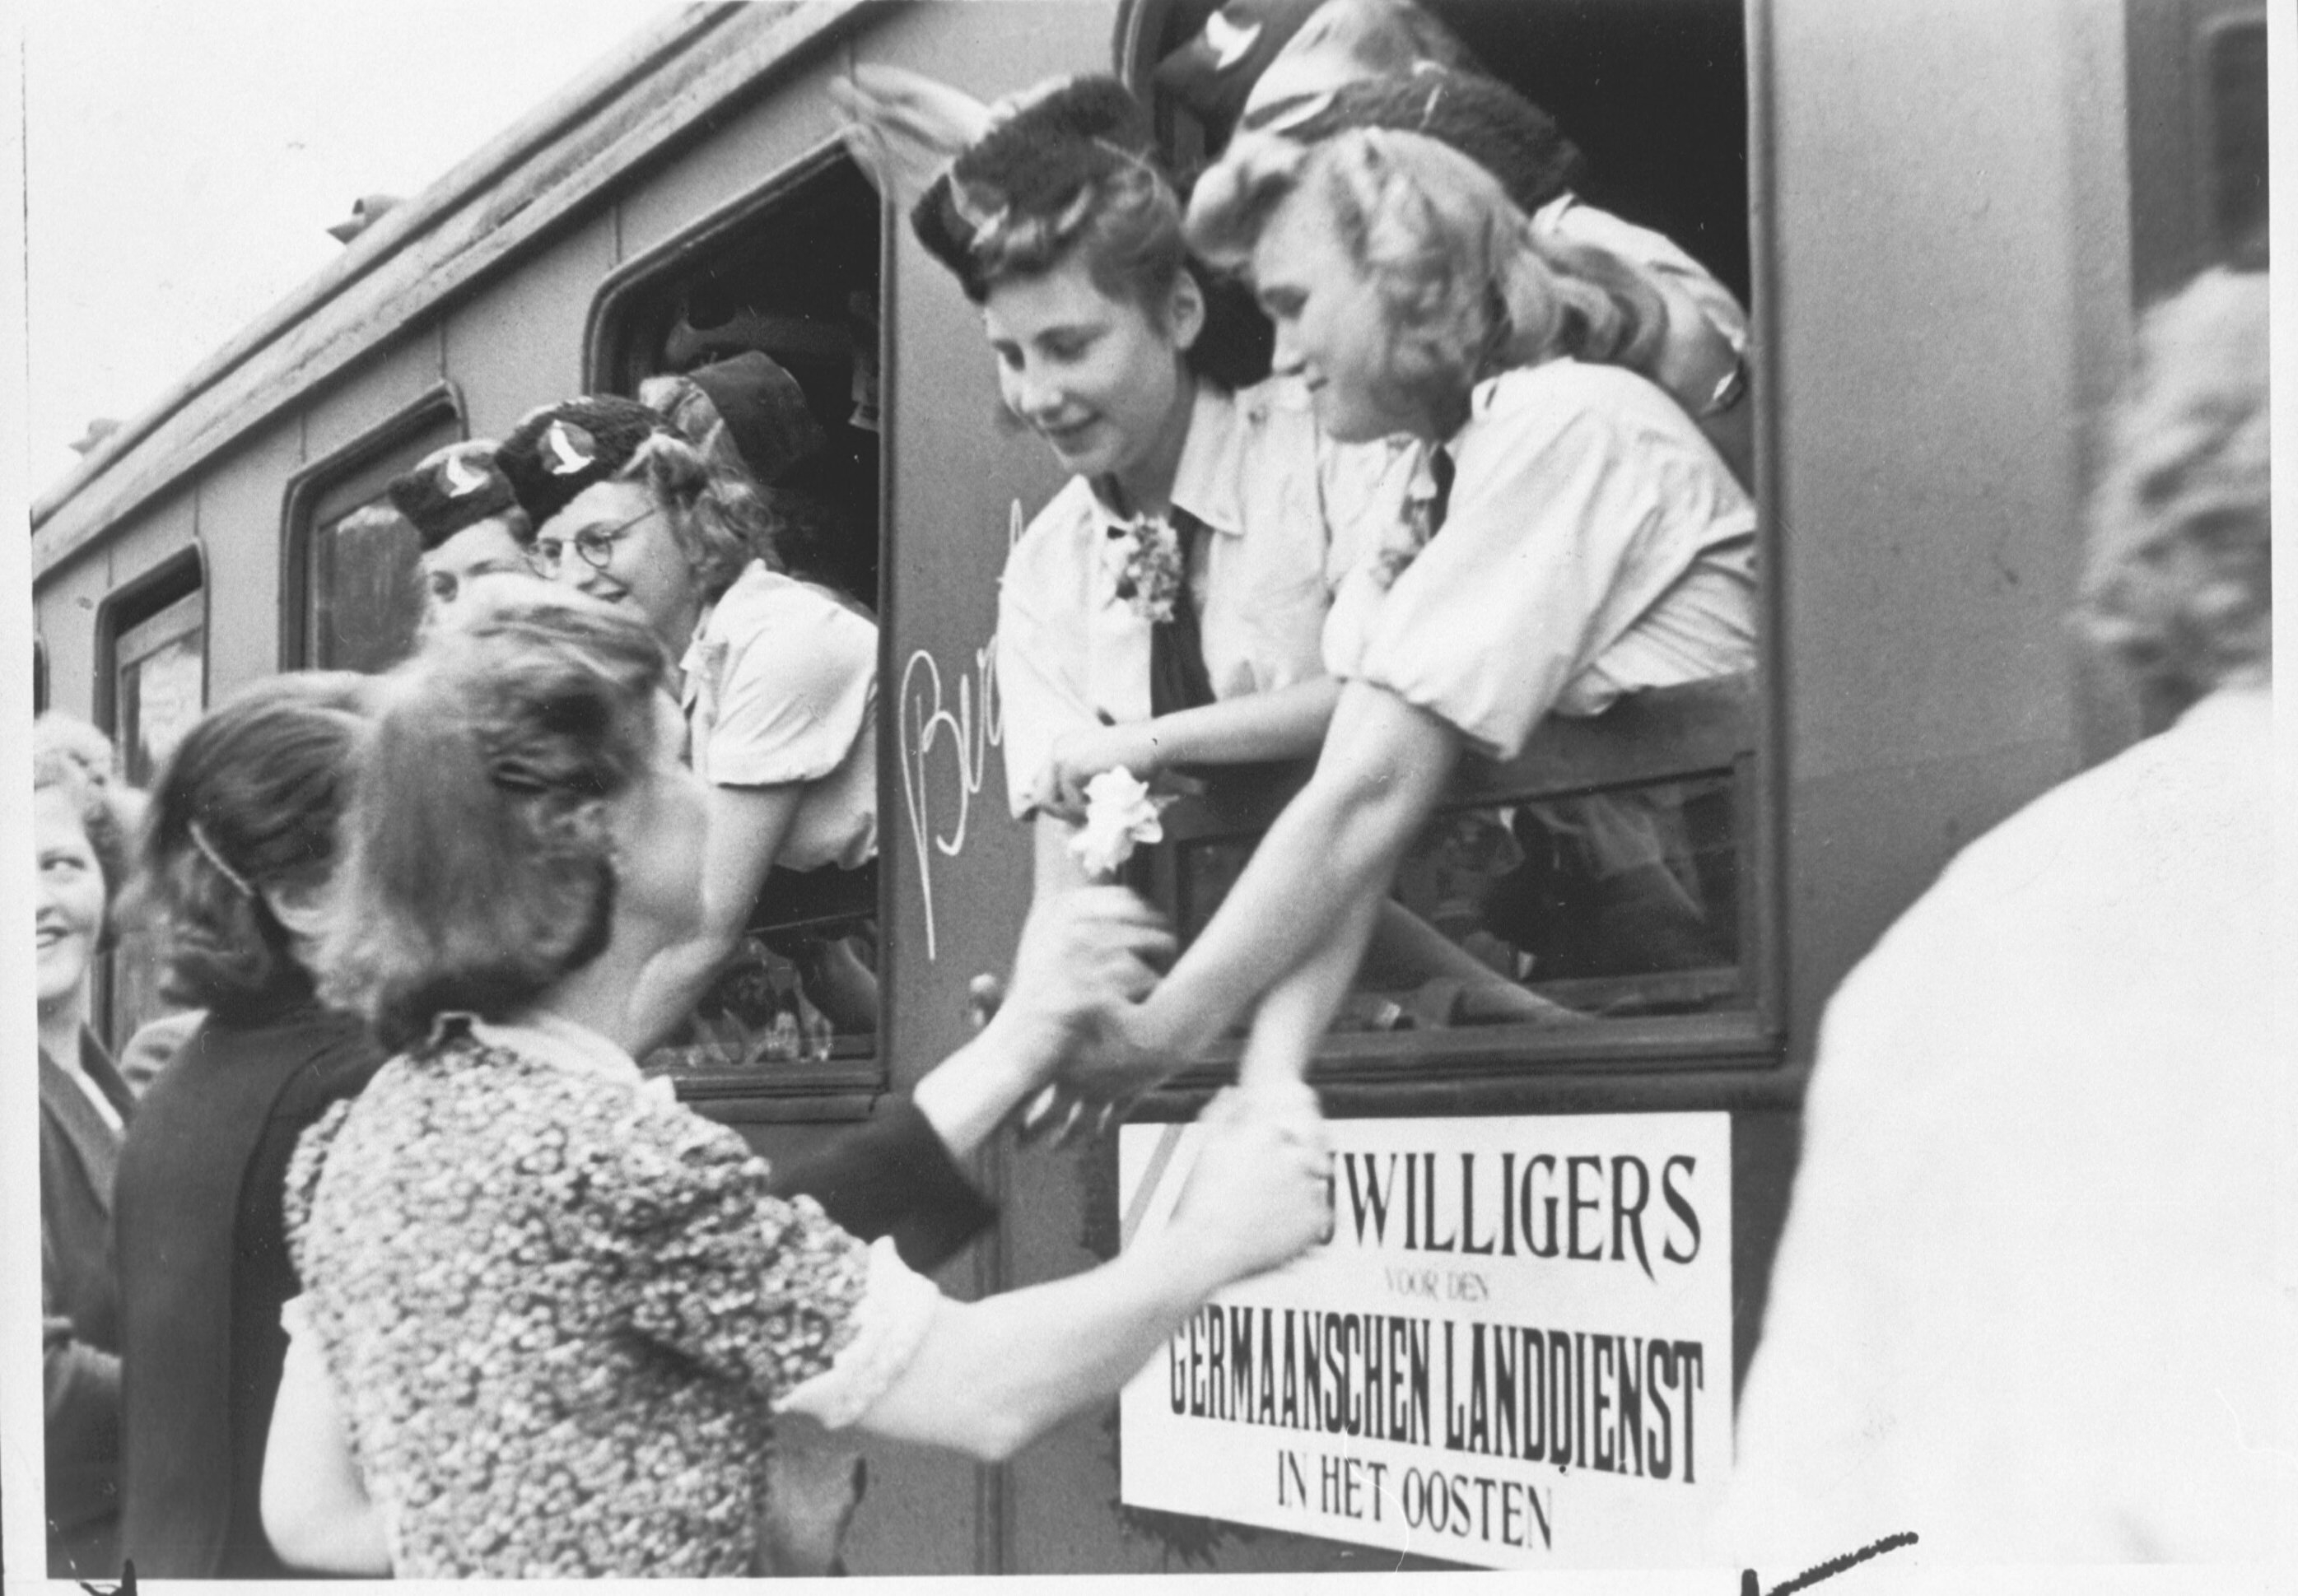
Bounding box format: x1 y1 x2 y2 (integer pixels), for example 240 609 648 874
281 388 462 671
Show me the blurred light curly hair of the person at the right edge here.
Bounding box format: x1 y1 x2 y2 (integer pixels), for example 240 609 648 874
2075 271 2272 707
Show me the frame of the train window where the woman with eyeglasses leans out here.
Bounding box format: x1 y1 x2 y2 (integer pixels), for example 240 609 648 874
581 137 901 1123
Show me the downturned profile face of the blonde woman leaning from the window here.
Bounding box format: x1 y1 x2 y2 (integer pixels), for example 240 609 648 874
1252 186 1436 443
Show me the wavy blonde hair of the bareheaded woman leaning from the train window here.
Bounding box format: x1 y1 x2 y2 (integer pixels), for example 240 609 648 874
1188 128 1666 421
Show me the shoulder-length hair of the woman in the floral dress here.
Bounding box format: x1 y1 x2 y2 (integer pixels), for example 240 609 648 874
319 576 666 1049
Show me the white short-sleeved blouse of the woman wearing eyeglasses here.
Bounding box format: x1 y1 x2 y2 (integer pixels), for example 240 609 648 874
680 561 878 870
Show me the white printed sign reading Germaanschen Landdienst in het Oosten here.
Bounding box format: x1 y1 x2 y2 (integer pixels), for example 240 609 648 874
1116 1114 1731 1569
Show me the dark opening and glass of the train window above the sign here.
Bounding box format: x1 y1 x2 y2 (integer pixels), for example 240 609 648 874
1119 0 1774 1073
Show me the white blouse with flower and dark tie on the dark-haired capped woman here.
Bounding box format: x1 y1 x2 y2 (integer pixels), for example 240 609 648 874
997 379 1411 817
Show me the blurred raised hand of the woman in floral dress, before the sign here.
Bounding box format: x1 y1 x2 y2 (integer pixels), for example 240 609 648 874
1170 1086 1333 1291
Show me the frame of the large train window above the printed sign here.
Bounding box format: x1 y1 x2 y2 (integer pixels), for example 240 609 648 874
1112 0 1788 1093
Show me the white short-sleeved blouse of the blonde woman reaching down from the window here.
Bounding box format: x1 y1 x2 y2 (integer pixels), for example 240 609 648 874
1326 361 1755 760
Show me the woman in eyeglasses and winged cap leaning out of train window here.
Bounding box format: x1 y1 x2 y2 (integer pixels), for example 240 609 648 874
496 395 878 1054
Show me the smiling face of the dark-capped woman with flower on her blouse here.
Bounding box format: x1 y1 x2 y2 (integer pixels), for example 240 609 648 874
981 253 1204 500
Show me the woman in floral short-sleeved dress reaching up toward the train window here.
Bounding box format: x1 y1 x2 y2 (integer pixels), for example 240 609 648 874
264 581 1331 1578
